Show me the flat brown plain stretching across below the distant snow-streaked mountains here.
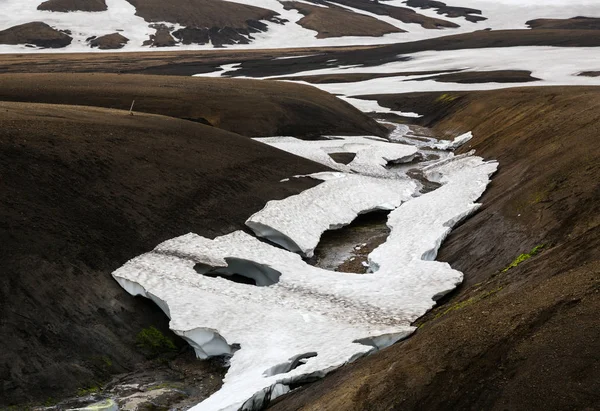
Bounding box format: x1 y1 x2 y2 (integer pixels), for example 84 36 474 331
0 29 600 77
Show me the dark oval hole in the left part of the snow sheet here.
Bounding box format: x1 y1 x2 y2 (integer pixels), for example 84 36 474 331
194 257 281 287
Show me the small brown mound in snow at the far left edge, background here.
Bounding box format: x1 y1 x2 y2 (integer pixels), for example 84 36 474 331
0 21 73 48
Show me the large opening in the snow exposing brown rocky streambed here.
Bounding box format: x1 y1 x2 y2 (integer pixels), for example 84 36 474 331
308 210 390 274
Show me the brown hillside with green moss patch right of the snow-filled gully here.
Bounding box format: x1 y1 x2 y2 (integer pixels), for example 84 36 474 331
272 87 600 411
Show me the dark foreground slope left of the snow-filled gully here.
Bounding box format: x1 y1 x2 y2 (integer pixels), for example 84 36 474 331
0 102 324 409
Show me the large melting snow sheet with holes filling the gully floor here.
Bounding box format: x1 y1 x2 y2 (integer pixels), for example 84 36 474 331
113 126 497 411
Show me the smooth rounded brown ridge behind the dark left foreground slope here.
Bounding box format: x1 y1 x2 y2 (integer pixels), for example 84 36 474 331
0 74 387 138
